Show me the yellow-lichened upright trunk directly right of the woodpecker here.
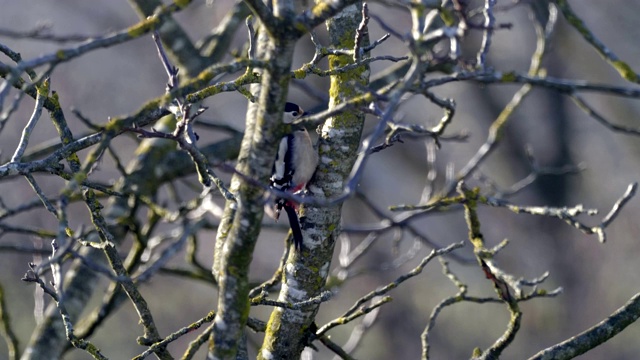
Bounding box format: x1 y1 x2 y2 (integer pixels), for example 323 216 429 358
258 4 369 359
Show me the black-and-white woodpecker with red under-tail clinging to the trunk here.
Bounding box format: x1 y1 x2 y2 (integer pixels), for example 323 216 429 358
271 102 318 250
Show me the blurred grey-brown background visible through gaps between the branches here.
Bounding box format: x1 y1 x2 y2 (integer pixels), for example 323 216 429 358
0 0 640 360
